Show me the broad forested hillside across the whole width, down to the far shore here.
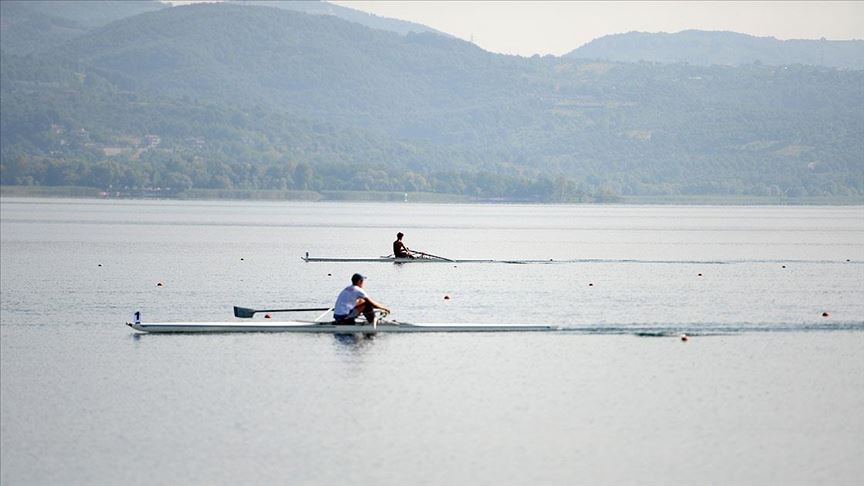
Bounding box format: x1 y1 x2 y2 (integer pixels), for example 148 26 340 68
0 4 864 201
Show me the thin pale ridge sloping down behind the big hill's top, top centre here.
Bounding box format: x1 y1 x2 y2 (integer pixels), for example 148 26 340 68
230 0 452 37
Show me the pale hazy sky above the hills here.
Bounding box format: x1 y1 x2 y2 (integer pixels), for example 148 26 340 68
332 1 864 56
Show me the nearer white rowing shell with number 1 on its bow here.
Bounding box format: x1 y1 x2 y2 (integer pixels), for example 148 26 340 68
126 321 560 334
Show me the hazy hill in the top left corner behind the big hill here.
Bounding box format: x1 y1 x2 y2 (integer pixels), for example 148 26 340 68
0 0 168 54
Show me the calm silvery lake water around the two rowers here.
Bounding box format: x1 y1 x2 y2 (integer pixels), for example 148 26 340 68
0 198 864 484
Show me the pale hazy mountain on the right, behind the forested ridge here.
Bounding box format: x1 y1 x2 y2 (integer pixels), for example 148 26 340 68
566 30 864 69
